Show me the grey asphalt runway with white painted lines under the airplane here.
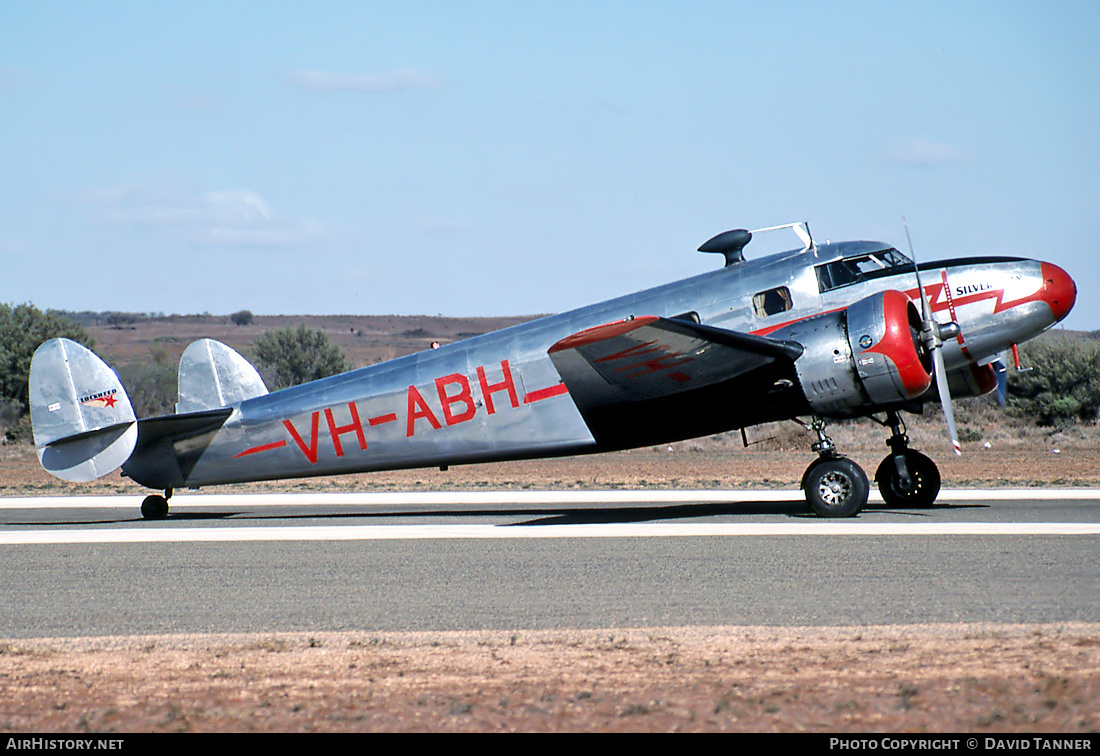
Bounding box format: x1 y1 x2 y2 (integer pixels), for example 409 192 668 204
0 490 1100 638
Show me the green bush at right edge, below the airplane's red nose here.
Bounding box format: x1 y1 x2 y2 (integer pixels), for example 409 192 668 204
1008 338 1100 426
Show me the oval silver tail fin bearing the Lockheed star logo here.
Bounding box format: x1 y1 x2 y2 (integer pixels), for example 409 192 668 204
29 339 138 482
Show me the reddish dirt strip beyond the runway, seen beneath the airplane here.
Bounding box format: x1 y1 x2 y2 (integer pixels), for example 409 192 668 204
0 428 1100 501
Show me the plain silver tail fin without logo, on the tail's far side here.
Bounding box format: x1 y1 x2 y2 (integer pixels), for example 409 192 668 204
176 339 267 414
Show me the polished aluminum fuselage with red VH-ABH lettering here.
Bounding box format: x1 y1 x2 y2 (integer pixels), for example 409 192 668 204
146 242 1057 487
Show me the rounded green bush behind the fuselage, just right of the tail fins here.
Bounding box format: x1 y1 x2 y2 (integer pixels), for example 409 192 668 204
253 324 351 388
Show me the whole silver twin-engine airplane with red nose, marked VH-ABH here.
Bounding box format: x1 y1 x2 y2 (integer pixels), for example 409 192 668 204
30 222 1077 519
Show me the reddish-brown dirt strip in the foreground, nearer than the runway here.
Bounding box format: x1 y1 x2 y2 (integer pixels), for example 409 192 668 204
0 625 1100 733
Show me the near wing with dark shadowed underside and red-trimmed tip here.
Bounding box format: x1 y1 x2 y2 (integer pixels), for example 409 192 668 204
549 316 803 447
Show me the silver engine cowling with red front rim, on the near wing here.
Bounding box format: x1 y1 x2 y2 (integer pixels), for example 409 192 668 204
770 291 933 417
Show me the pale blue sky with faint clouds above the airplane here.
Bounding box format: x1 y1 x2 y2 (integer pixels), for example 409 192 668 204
0 0 1100 330
